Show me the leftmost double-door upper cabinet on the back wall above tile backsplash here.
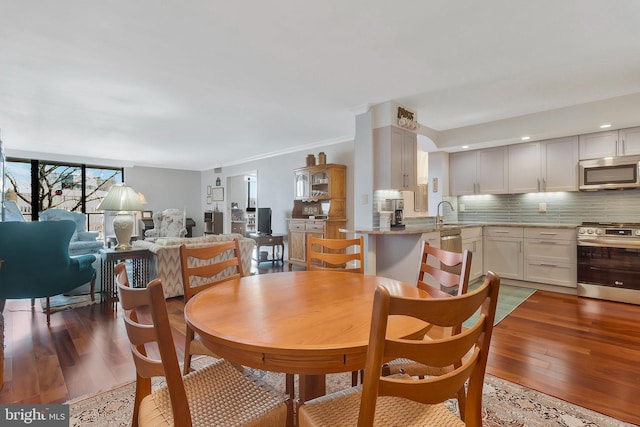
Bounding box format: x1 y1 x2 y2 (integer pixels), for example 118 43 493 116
449 147 509 196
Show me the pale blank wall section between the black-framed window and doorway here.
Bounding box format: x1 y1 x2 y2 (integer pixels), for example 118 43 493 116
124 166 206 236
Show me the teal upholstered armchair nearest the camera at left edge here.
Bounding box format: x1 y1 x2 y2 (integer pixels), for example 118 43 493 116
0 220 96 324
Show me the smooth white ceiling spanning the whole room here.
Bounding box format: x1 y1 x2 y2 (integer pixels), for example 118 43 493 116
0 0 640 170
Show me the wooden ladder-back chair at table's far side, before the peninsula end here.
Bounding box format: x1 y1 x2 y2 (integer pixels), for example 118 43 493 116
307 234 364 273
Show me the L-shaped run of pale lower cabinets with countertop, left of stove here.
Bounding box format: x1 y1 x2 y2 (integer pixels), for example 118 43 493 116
353 222 577 294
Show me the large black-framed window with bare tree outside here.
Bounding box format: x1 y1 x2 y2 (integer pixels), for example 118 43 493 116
5 158 124 232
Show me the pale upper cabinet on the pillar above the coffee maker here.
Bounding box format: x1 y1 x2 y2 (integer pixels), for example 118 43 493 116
373 126 418 191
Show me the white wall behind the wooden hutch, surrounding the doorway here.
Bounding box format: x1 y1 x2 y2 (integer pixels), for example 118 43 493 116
199 142 354 236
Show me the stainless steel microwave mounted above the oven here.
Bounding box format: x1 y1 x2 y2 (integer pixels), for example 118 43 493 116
580 156 640 190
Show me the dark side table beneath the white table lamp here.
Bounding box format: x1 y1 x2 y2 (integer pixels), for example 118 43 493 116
100 248 153 304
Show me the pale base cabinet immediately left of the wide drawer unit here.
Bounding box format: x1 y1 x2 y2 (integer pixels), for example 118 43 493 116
483 226 524 280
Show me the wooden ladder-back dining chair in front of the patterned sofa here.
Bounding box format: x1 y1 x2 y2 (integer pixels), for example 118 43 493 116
180 239 244 374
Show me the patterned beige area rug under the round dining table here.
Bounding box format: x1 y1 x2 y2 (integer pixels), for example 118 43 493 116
67 358 633 427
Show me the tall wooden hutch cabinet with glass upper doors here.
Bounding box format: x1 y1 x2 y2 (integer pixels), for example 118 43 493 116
287 164 347 270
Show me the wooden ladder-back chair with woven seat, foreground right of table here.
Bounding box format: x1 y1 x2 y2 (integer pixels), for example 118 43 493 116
298 272 500 427
